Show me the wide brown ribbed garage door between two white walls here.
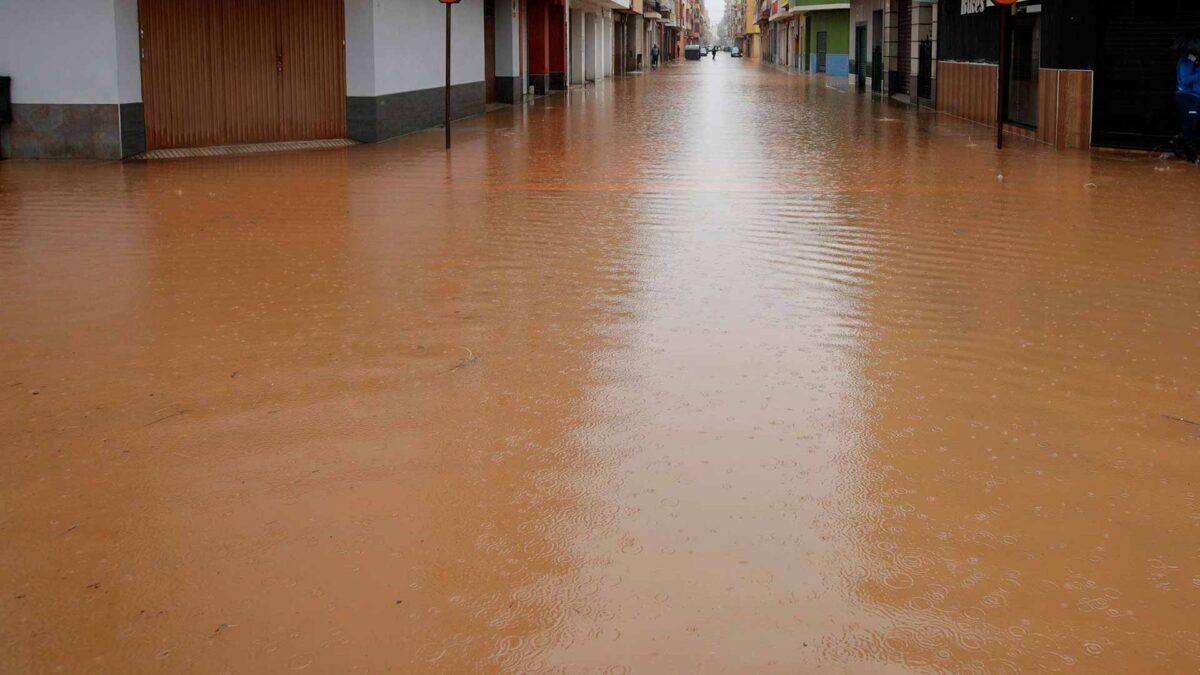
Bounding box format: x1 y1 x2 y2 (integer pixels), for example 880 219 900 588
138 0 346 149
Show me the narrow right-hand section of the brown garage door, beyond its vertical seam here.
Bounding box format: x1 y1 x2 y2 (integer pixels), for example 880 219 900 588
282 0 346 141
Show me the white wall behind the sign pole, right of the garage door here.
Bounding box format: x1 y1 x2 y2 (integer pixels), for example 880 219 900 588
374 0 484 96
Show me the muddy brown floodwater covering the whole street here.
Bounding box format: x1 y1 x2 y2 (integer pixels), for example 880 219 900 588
0 59 1200 674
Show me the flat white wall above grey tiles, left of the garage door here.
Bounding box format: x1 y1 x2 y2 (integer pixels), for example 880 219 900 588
0 0 120 103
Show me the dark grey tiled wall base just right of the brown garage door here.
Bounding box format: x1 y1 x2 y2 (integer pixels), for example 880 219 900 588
346 82 484 143
